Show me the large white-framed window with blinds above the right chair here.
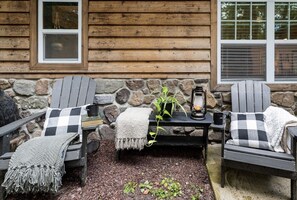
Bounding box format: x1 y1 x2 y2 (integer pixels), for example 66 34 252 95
217 0 297 83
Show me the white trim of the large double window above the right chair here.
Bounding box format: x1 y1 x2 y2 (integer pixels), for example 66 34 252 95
217 0 297 84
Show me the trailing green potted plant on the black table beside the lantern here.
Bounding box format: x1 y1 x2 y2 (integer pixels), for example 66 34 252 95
147 86 187 146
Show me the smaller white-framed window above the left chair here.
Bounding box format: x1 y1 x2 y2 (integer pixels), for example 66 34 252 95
37 0 82 64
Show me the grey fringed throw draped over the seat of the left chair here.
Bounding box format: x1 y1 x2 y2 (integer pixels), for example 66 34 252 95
2 133 77 193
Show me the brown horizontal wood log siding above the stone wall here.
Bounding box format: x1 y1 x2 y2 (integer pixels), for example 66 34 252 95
0 0 216 78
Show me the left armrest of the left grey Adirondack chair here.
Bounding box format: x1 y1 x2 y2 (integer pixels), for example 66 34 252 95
0 110 46 137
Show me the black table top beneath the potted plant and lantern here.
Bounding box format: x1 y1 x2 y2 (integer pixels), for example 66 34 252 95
149 112 213 126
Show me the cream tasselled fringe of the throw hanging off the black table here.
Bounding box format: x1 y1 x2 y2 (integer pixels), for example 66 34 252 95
115 137 147 150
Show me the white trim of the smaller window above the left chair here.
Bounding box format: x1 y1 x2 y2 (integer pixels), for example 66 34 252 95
37 0 82 64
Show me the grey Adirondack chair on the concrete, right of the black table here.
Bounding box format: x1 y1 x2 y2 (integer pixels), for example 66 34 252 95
221 81 297 200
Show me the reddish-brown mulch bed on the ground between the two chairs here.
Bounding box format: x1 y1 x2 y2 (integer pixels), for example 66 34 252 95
8 141 215 200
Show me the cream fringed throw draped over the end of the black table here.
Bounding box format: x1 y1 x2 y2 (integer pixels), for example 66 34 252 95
115 108 152 150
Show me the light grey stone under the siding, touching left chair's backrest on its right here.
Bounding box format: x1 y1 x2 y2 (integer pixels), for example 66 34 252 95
95 79 124 94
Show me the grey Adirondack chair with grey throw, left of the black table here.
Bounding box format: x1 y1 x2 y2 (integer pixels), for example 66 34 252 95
0 76 96 198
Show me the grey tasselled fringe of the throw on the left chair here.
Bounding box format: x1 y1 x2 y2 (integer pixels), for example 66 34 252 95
2 165 65 194
